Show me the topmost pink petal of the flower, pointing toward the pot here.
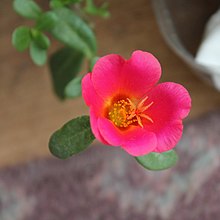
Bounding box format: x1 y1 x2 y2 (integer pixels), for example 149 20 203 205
120 50 161 97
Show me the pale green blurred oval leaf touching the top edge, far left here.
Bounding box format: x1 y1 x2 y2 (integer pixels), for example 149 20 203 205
13 0 42 19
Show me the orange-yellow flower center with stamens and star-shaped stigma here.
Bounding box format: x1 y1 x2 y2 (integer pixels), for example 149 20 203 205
108 96 153 128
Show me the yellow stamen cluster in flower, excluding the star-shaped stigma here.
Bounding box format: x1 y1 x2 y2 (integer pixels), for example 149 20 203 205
108 99 137 128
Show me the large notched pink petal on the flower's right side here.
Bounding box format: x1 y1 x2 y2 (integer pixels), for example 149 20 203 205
145 82 191 152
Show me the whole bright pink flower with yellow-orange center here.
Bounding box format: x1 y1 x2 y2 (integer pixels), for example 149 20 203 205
82 51 191 156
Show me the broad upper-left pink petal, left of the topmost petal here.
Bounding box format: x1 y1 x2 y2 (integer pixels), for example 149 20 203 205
92 54 125 100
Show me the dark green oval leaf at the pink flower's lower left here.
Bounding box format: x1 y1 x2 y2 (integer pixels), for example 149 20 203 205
49 116 95 159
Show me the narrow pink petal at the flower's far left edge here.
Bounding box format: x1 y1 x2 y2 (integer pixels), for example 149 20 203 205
82 73 104 115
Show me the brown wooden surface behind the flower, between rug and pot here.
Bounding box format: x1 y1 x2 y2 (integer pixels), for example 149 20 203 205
0 0 220 166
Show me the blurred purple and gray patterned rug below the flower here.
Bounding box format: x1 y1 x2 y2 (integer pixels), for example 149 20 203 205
0 112 220 220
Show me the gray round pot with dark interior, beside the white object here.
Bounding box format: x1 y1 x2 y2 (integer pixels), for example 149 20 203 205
152 0 220 87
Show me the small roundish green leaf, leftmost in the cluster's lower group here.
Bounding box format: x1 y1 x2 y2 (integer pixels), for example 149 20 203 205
12 26 31 51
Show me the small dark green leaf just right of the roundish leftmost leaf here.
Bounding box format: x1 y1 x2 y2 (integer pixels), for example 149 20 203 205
31 29 50 50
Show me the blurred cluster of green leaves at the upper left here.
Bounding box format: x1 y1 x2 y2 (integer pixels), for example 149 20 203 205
12 0 109 99
